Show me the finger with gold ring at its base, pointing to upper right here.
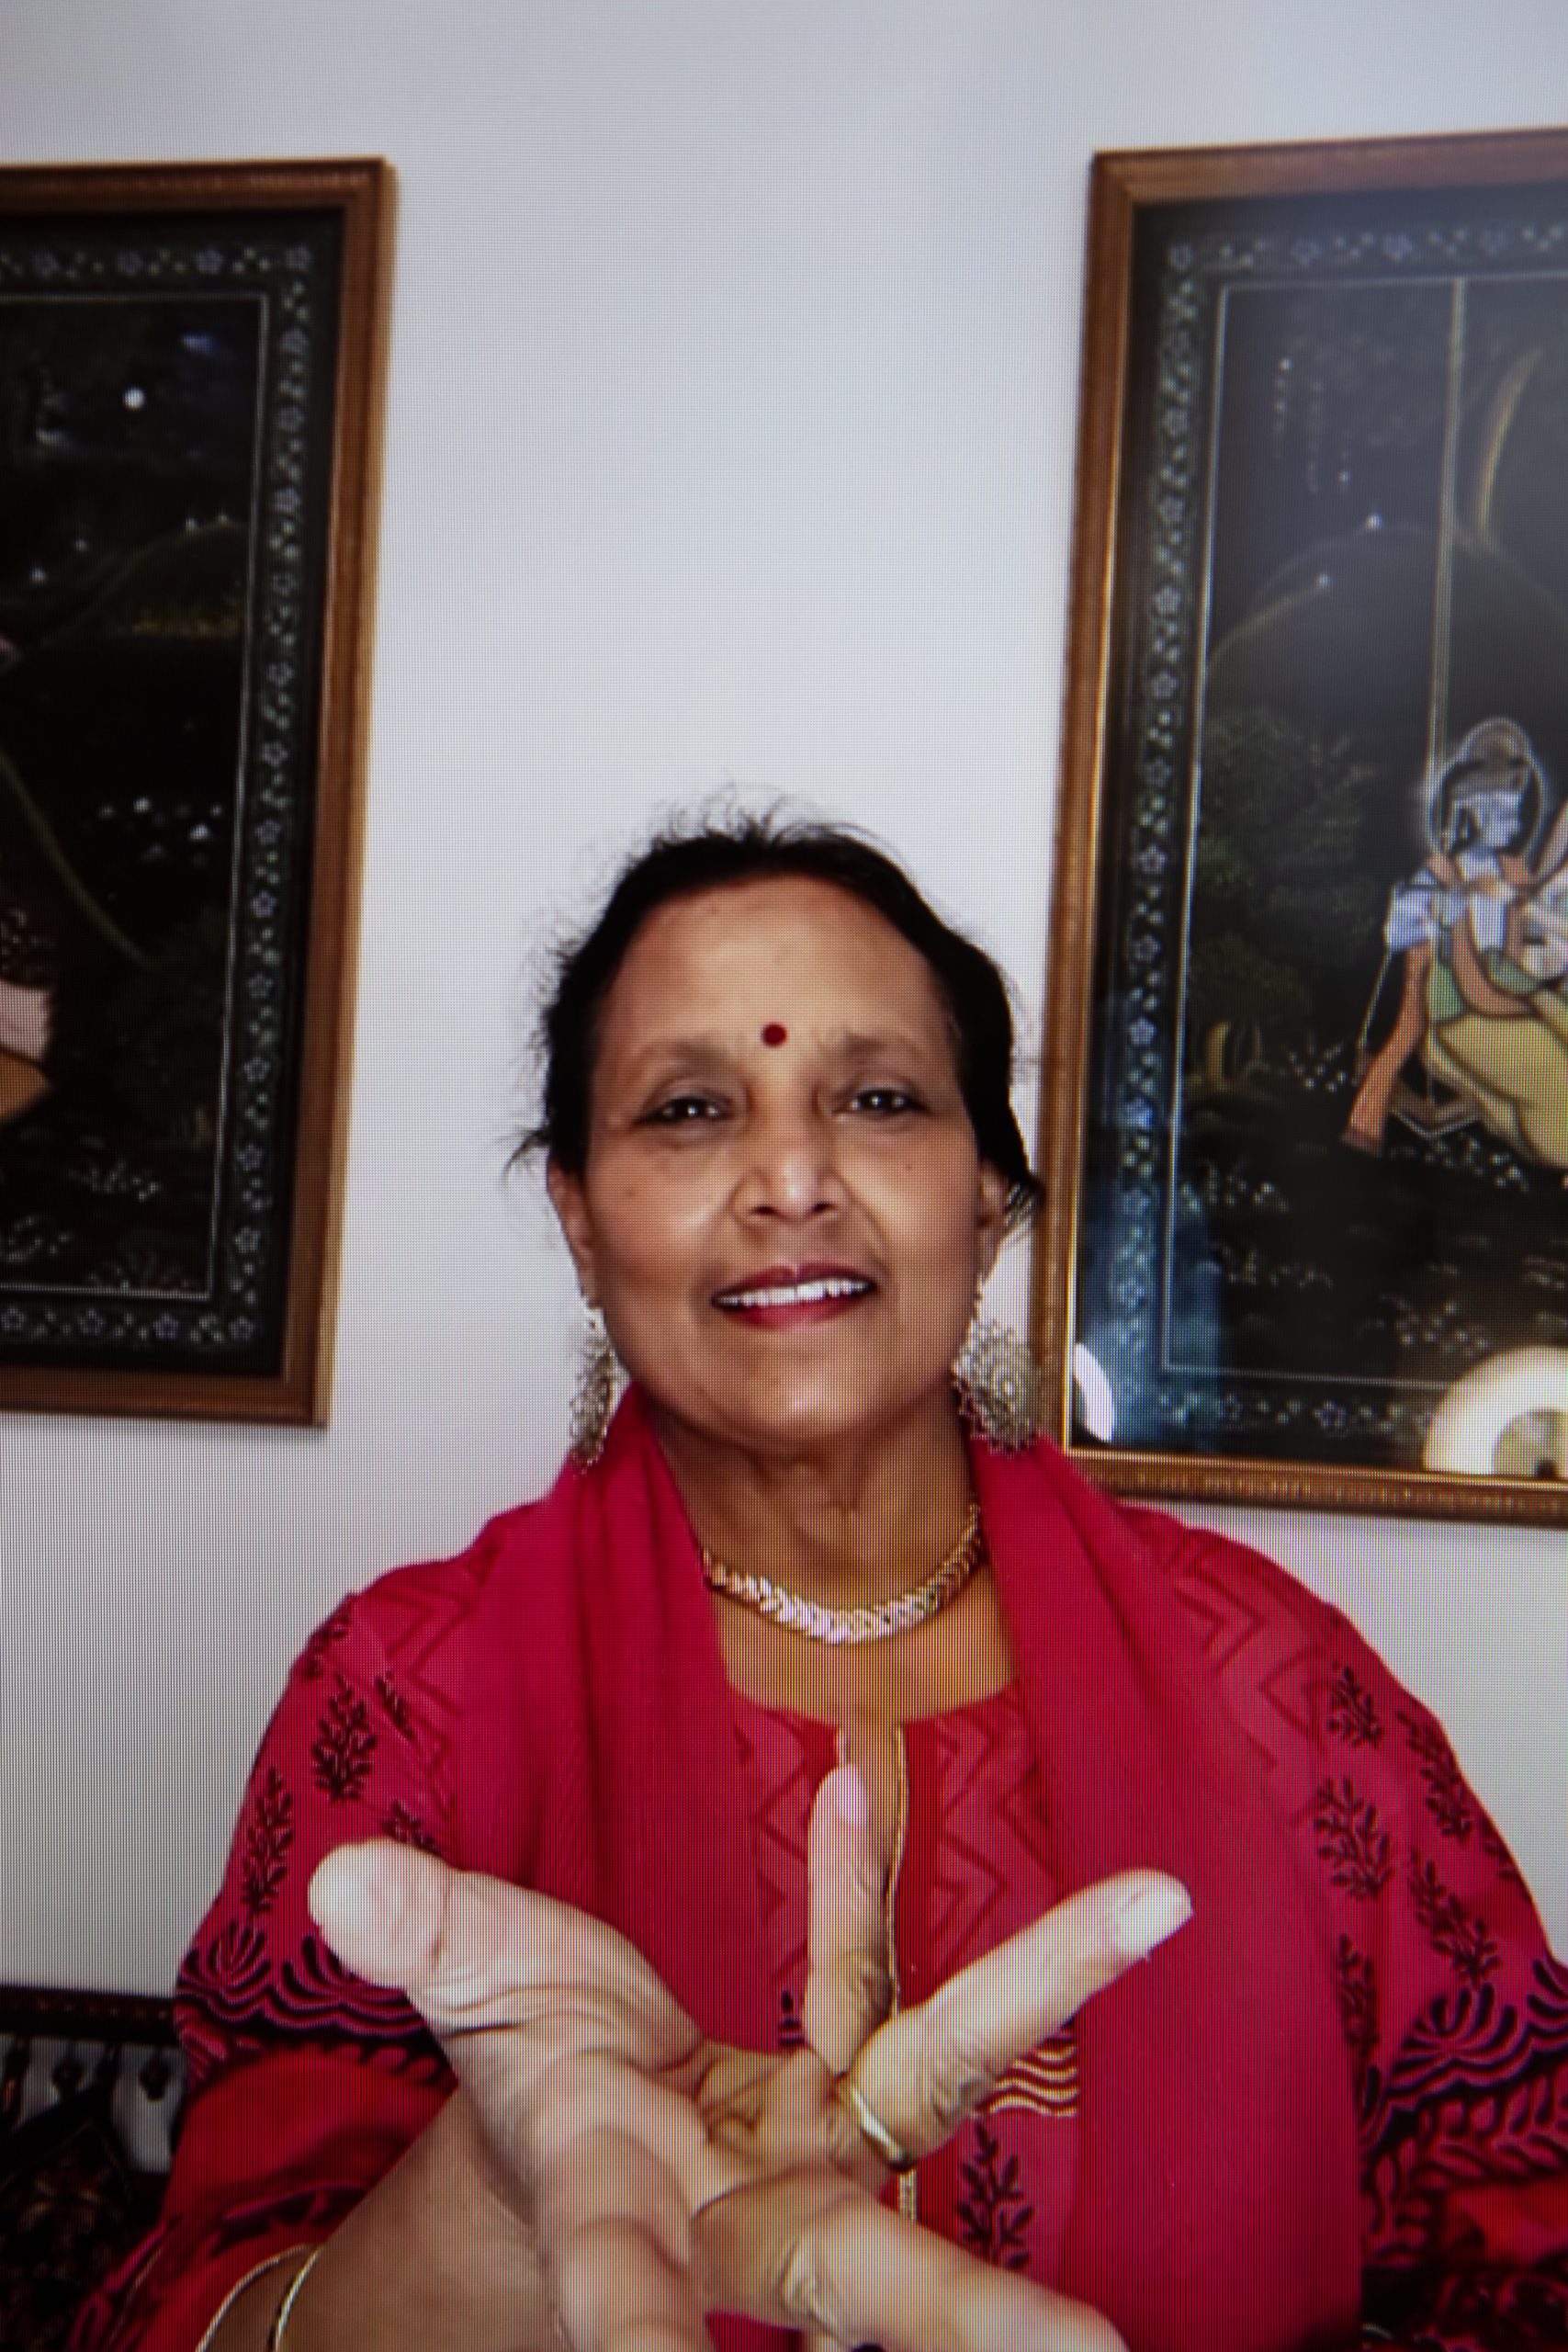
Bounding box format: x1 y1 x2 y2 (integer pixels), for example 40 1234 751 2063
853 1870 1192 2157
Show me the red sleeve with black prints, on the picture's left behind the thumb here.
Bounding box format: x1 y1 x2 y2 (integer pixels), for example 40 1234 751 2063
73 1571 456 2352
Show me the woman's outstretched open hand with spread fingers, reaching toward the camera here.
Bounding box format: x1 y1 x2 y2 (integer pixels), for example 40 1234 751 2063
310 1767 1190 2352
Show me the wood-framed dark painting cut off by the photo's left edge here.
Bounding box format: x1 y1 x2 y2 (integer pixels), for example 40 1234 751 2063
0 163 392 1423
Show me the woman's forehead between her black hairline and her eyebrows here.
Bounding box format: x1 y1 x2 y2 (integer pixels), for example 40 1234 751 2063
602 875 950 1049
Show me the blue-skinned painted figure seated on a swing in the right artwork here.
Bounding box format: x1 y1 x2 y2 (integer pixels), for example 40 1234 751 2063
1345 719 1568 1169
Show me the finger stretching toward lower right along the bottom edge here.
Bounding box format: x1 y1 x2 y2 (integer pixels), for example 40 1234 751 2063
696 2168 1126 2352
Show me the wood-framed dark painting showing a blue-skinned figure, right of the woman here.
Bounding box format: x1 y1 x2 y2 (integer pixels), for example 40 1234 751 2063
1037 131 1568 1521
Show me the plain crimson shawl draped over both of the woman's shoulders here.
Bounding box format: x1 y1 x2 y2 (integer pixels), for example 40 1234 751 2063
458 1393 1361 2352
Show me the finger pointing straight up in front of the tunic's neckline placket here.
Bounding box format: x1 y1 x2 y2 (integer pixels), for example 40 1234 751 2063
802 1764 894 2075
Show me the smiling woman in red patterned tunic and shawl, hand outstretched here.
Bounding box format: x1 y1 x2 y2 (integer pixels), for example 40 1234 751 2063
77 820 1568 2352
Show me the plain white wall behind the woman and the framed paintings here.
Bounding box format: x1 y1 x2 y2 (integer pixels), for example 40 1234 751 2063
0 0 1568 1990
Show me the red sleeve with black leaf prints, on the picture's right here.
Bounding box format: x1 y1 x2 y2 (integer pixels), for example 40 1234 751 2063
1173 1536 1568 2352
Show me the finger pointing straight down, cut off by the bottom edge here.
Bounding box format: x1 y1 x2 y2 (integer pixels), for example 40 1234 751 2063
536 2131 710 2352
